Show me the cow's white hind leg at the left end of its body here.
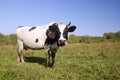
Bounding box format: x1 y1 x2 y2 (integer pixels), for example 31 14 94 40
18 39 24 63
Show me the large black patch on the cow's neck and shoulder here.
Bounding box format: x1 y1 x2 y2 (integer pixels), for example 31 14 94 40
45 23 60 45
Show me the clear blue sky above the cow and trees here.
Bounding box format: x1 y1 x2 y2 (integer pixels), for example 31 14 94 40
0 0 120 36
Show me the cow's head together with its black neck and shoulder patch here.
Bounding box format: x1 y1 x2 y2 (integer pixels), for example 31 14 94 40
46 22 76 46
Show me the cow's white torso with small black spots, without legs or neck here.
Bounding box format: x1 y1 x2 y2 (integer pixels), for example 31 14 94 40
16 26 48 49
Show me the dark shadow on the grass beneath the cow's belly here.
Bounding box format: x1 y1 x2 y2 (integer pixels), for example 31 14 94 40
24 57 46 65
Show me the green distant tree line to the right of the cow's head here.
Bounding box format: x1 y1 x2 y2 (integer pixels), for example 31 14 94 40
68 31 120 44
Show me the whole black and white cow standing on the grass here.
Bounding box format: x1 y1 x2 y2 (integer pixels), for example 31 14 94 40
16 22 76 67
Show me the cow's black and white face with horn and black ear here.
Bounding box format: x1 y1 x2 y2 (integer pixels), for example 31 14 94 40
58 22 76 46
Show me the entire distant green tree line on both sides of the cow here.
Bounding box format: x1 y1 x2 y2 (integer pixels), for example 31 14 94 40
0 31 120 45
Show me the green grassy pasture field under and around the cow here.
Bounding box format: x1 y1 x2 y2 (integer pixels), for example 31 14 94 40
0 42 120 80
